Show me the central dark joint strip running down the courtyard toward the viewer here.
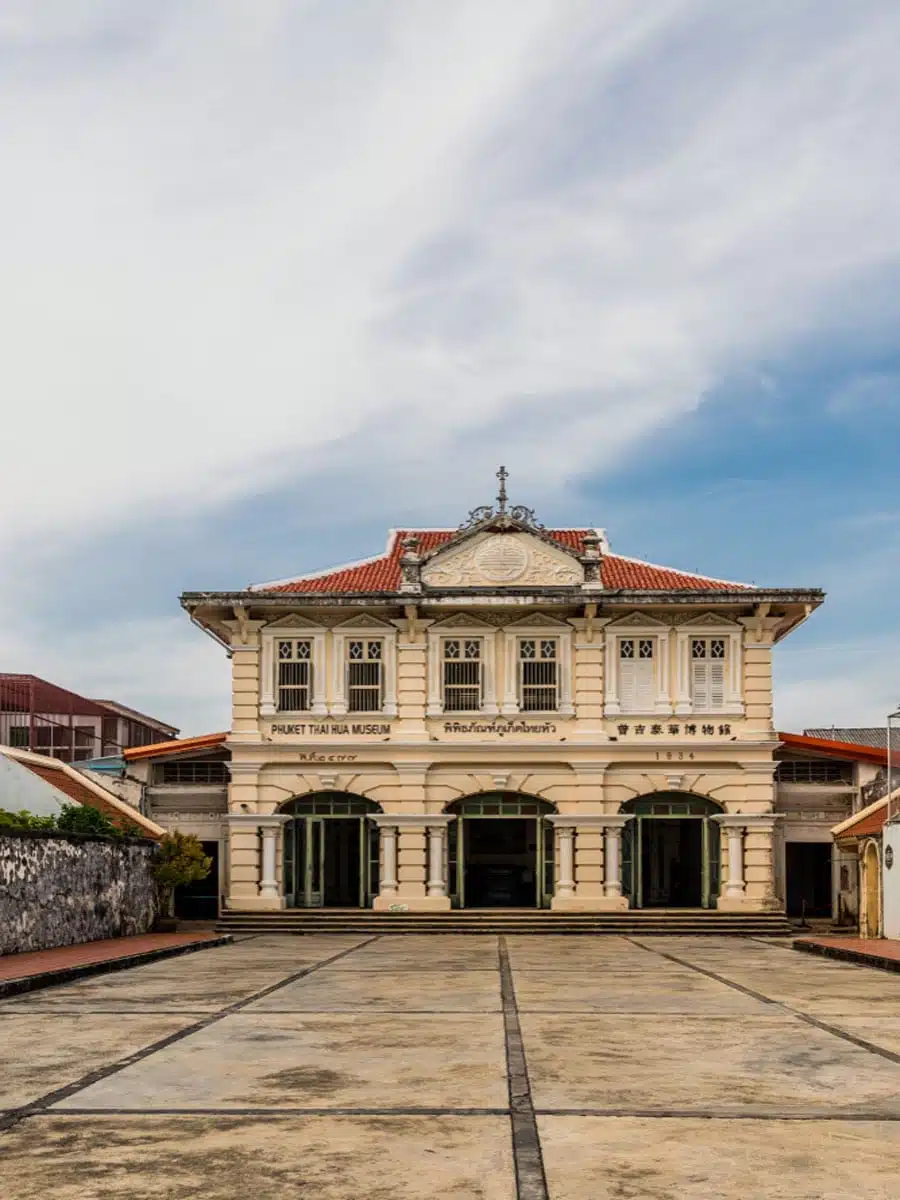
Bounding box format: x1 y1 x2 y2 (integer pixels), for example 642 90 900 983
498 937 550 1200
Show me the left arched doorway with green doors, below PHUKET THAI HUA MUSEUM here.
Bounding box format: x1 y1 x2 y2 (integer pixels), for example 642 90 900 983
281 792 382 908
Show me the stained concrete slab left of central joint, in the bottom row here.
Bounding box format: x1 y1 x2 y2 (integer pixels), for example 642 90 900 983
2 1116 516 1200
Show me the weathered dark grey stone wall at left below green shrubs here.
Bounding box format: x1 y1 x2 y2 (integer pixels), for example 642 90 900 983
0 829 156 954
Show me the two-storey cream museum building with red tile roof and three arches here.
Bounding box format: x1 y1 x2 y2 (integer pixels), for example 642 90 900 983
181 474 823 912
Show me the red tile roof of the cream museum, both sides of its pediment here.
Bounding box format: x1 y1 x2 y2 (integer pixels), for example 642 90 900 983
252 529 748 593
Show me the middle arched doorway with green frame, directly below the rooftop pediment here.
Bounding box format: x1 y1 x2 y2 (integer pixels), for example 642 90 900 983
445 792 556 908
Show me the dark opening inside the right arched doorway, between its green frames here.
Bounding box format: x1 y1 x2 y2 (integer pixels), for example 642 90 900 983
641 817 703 908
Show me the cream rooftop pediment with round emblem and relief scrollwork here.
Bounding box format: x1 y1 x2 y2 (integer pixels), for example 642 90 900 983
421 530 584 588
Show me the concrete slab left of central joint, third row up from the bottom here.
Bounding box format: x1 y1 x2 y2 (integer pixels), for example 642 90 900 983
248 967 502 1013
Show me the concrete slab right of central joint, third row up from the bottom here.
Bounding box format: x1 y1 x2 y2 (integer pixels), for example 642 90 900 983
515 967 768 1014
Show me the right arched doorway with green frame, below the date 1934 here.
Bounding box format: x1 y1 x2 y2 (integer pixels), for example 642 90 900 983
620 792 722 908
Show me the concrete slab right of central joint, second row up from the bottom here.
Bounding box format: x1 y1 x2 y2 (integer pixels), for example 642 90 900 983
521 1013 900 1117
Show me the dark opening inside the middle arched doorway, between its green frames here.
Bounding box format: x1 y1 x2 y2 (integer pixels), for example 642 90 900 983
466 817 538 908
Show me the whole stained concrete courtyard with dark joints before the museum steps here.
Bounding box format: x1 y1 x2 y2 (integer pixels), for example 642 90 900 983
0 936 900 1200
